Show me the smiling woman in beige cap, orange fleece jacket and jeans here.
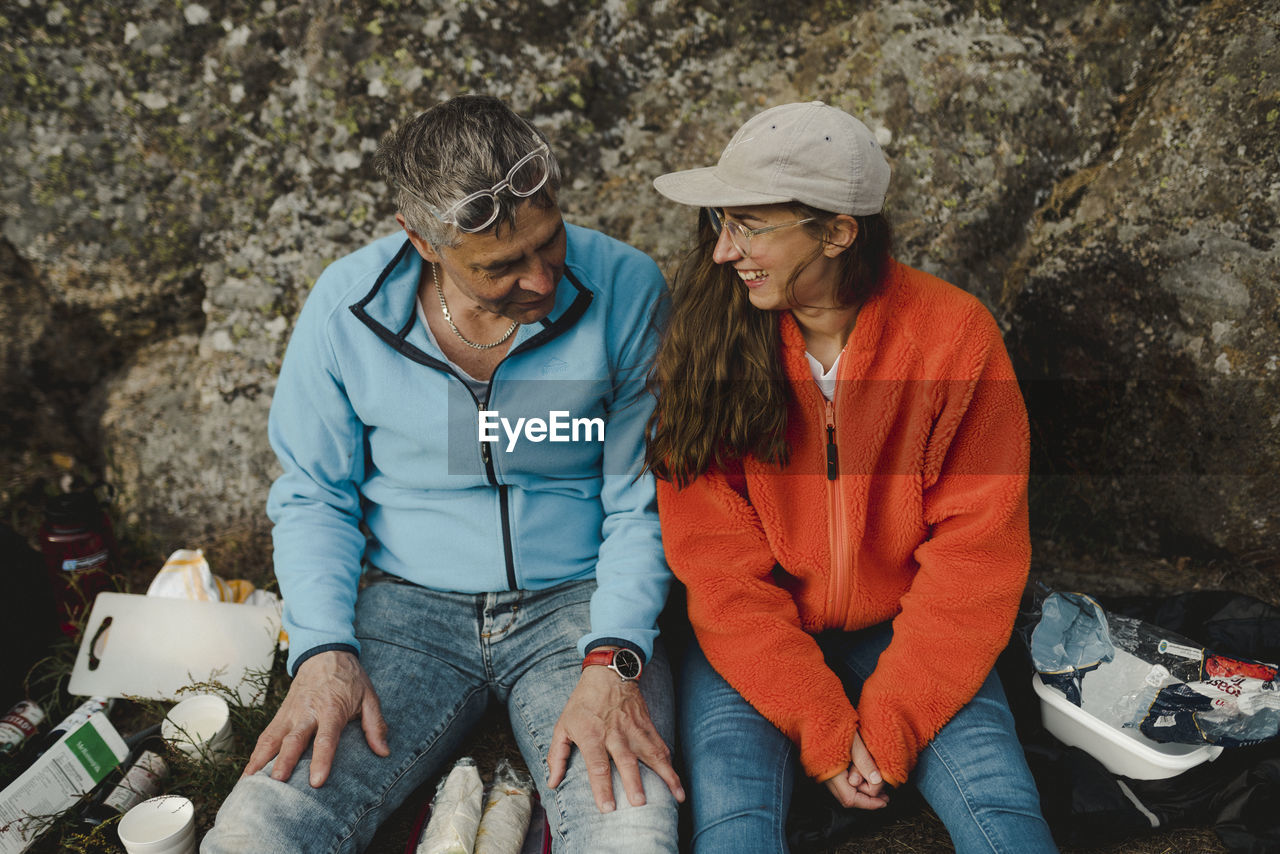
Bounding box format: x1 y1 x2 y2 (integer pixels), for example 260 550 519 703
646 102 1055 854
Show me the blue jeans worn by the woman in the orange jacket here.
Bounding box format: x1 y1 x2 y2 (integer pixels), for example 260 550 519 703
678 624 1057 854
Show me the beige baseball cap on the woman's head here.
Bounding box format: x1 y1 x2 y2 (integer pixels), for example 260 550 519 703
653 101 890 216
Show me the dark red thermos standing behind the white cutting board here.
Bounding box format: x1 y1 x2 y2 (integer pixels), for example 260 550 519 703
40 490 115 636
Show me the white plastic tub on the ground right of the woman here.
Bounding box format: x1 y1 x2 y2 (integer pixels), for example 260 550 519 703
1032 650 1222 780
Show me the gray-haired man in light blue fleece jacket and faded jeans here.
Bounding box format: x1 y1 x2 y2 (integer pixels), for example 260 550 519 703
202 96 685 854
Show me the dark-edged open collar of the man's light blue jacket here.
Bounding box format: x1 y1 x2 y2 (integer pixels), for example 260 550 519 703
351 238 593 367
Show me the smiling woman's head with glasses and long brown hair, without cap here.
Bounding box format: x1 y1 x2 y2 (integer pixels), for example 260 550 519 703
649 201 892 483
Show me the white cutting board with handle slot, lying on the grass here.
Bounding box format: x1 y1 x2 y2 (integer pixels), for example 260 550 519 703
68 593 280 705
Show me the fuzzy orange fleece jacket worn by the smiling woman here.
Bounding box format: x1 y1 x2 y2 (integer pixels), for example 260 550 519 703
658 264 1030 785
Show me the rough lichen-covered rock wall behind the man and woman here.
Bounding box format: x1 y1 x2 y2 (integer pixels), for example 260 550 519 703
0 0 1280 560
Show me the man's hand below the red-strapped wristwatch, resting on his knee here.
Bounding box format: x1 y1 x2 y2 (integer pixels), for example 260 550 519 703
547 667 685 813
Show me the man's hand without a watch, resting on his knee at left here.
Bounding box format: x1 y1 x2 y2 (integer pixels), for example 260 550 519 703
244 650 392 787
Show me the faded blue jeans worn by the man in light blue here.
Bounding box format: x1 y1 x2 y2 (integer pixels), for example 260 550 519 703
201 576 677 854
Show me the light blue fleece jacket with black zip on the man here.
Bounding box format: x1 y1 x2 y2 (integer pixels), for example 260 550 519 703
268 225 671 673
